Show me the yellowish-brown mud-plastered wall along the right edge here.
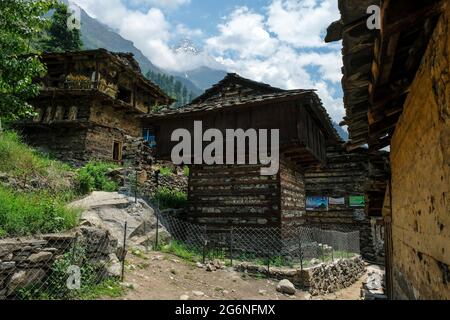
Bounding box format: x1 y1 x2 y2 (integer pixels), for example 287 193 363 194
391 6 450 299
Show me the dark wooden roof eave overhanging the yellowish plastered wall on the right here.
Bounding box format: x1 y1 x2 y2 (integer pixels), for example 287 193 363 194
341 0 446 149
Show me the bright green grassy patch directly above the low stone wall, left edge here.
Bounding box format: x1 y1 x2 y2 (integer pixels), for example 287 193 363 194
0 186 80 237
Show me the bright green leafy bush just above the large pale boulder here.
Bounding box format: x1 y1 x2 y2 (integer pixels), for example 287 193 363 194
77 162 118 194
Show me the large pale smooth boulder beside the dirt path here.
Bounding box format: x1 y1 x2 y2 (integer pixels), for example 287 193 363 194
70 192 170 247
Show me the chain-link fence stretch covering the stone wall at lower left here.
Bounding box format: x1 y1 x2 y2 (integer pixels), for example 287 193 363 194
0 226 126 300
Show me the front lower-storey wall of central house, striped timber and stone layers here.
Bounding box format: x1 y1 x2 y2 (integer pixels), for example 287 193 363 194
188 165 280 228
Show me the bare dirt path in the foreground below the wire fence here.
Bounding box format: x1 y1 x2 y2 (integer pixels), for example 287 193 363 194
110 252 362 300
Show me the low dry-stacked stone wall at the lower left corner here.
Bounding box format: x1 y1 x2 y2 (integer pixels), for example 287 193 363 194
0 227 122 300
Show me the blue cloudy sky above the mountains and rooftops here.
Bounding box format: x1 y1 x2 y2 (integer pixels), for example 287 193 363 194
72 0 344 122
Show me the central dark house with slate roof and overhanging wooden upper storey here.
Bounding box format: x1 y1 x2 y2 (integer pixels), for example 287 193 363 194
144 74 342 228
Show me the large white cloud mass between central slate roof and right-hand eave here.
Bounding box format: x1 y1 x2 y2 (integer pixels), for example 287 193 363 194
205 0 344 122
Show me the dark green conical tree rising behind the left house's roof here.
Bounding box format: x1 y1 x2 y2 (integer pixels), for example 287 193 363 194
42 3 83 52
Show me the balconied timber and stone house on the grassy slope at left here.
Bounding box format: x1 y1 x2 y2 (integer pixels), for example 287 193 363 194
16 49 173 165
